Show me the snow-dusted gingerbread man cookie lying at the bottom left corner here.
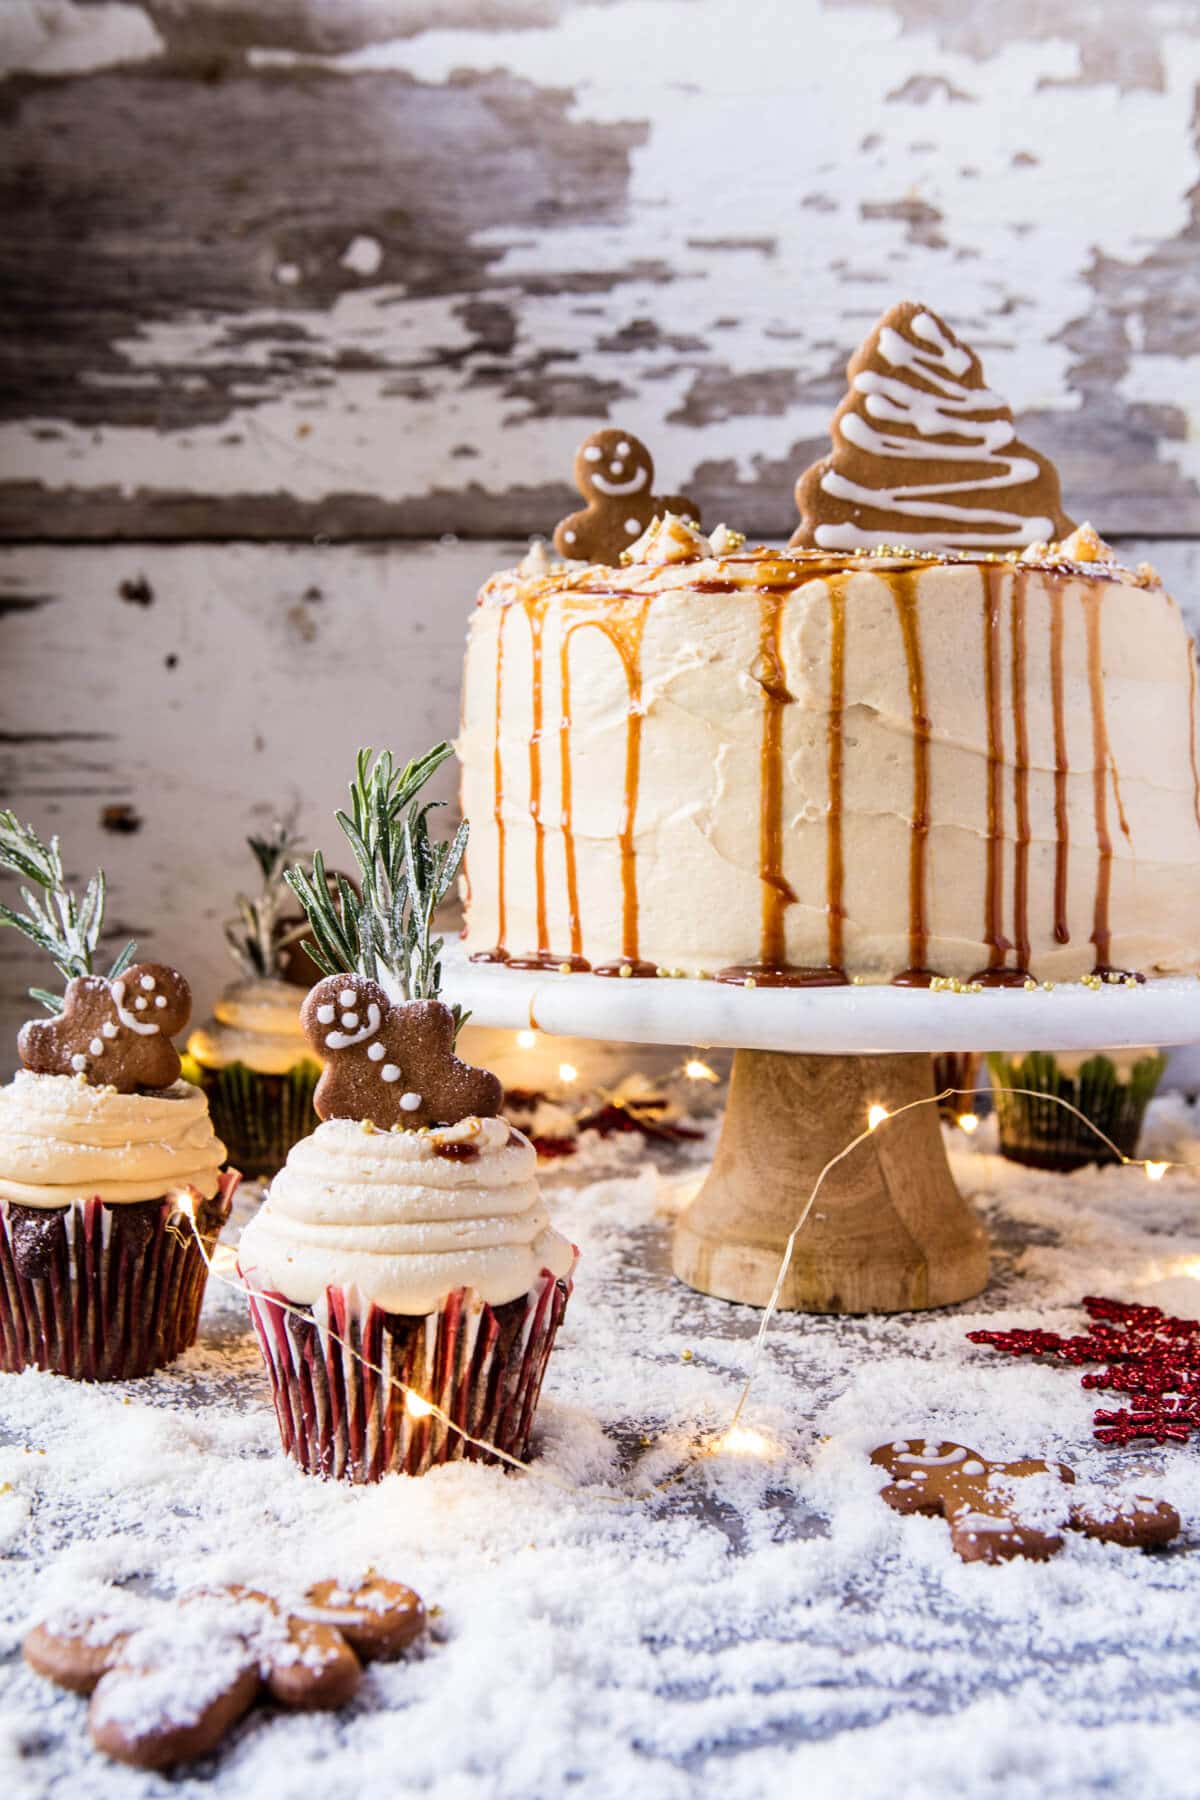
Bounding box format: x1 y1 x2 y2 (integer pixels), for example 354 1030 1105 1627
23 1575 425 1769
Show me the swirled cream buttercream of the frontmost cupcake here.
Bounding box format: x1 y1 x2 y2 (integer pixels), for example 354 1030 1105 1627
239 1118 576 1314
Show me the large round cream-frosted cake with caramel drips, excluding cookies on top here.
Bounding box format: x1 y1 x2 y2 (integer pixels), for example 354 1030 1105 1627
459 520 1200 983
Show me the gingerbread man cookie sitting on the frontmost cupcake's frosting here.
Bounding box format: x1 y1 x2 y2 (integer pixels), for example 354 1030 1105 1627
300 976 504 1130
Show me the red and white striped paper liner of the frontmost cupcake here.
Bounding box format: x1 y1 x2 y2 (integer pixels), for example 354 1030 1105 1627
250 1269 572 1481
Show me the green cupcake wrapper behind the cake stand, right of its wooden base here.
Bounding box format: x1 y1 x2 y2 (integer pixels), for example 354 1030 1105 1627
988 1049 1166 1174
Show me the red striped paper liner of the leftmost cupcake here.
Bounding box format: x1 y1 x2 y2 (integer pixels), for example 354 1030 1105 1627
0 1170 241 1381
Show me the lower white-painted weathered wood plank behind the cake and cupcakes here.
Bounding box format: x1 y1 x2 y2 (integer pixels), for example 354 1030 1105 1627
0 542 1200 1071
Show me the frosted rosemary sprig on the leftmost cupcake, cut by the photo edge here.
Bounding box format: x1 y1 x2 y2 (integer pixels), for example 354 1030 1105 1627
0 812 137 1013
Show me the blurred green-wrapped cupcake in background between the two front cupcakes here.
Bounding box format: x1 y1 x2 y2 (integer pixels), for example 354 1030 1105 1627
184 826 320 1175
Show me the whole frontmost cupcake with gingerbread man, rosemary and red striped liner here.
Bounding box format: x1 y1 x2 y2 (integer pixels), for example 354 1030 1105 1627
239 745 576 1481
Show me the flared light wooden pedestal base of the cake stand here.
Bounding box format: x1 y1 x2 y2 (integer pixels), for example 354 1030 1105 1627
673 1049 988 1312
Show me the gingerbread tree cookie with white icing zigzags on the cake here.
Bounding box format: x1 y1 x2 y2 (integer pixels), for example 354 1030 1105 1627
792 301 1074 551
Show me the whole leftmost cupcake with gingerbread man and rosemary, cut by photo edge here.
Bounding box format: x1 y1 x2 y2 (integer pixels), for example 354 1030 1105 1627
0 814 237 1381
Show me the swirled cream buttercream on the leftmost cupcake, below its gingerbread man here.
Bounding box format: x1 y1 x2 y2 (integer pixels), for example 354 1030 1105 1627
0 1071 225 1208
